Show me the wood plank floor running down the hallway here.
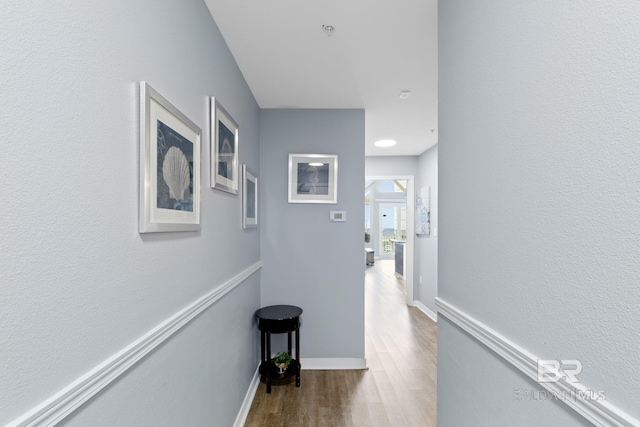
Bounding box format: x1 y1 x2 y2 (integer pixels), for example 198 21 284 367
245 260 436 427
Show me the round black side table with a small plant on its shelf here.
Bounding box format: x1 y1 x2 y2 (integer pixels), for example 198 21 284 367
255 305 302 393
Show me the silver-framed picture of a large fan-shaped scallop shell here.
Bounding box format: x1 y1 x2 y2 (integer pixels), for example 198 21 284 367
139 82 202 233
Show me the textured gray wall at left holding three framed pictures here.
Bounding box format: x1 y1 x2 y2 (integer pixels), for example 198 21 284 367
0 0 260 426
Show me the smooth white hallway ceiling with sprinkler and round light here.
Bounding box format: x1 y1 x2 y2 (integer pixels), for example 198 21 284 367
205 0 438 156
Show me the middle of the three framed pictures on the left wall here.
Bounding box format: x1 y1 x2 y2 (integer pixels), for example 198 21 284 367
211 97 239 194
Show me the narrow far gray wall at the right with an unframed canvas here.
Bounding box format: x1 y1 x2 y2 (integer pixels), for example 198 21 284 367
413 145 438 314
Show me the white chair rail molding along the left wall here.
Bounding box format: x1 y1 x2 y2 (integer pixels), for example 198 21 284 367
5 262 262 427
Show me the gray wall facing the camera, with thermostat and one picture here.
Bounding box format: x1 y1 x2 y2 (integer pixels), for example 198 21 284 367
260 110 364 359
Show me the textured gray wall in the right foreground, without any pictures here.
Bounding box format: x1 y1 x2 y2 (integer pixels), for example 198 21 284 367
438 0 640 427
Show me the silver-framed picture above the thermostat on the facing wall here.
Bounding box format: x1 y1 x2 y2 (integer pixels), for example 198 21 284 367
289 154 338 204
